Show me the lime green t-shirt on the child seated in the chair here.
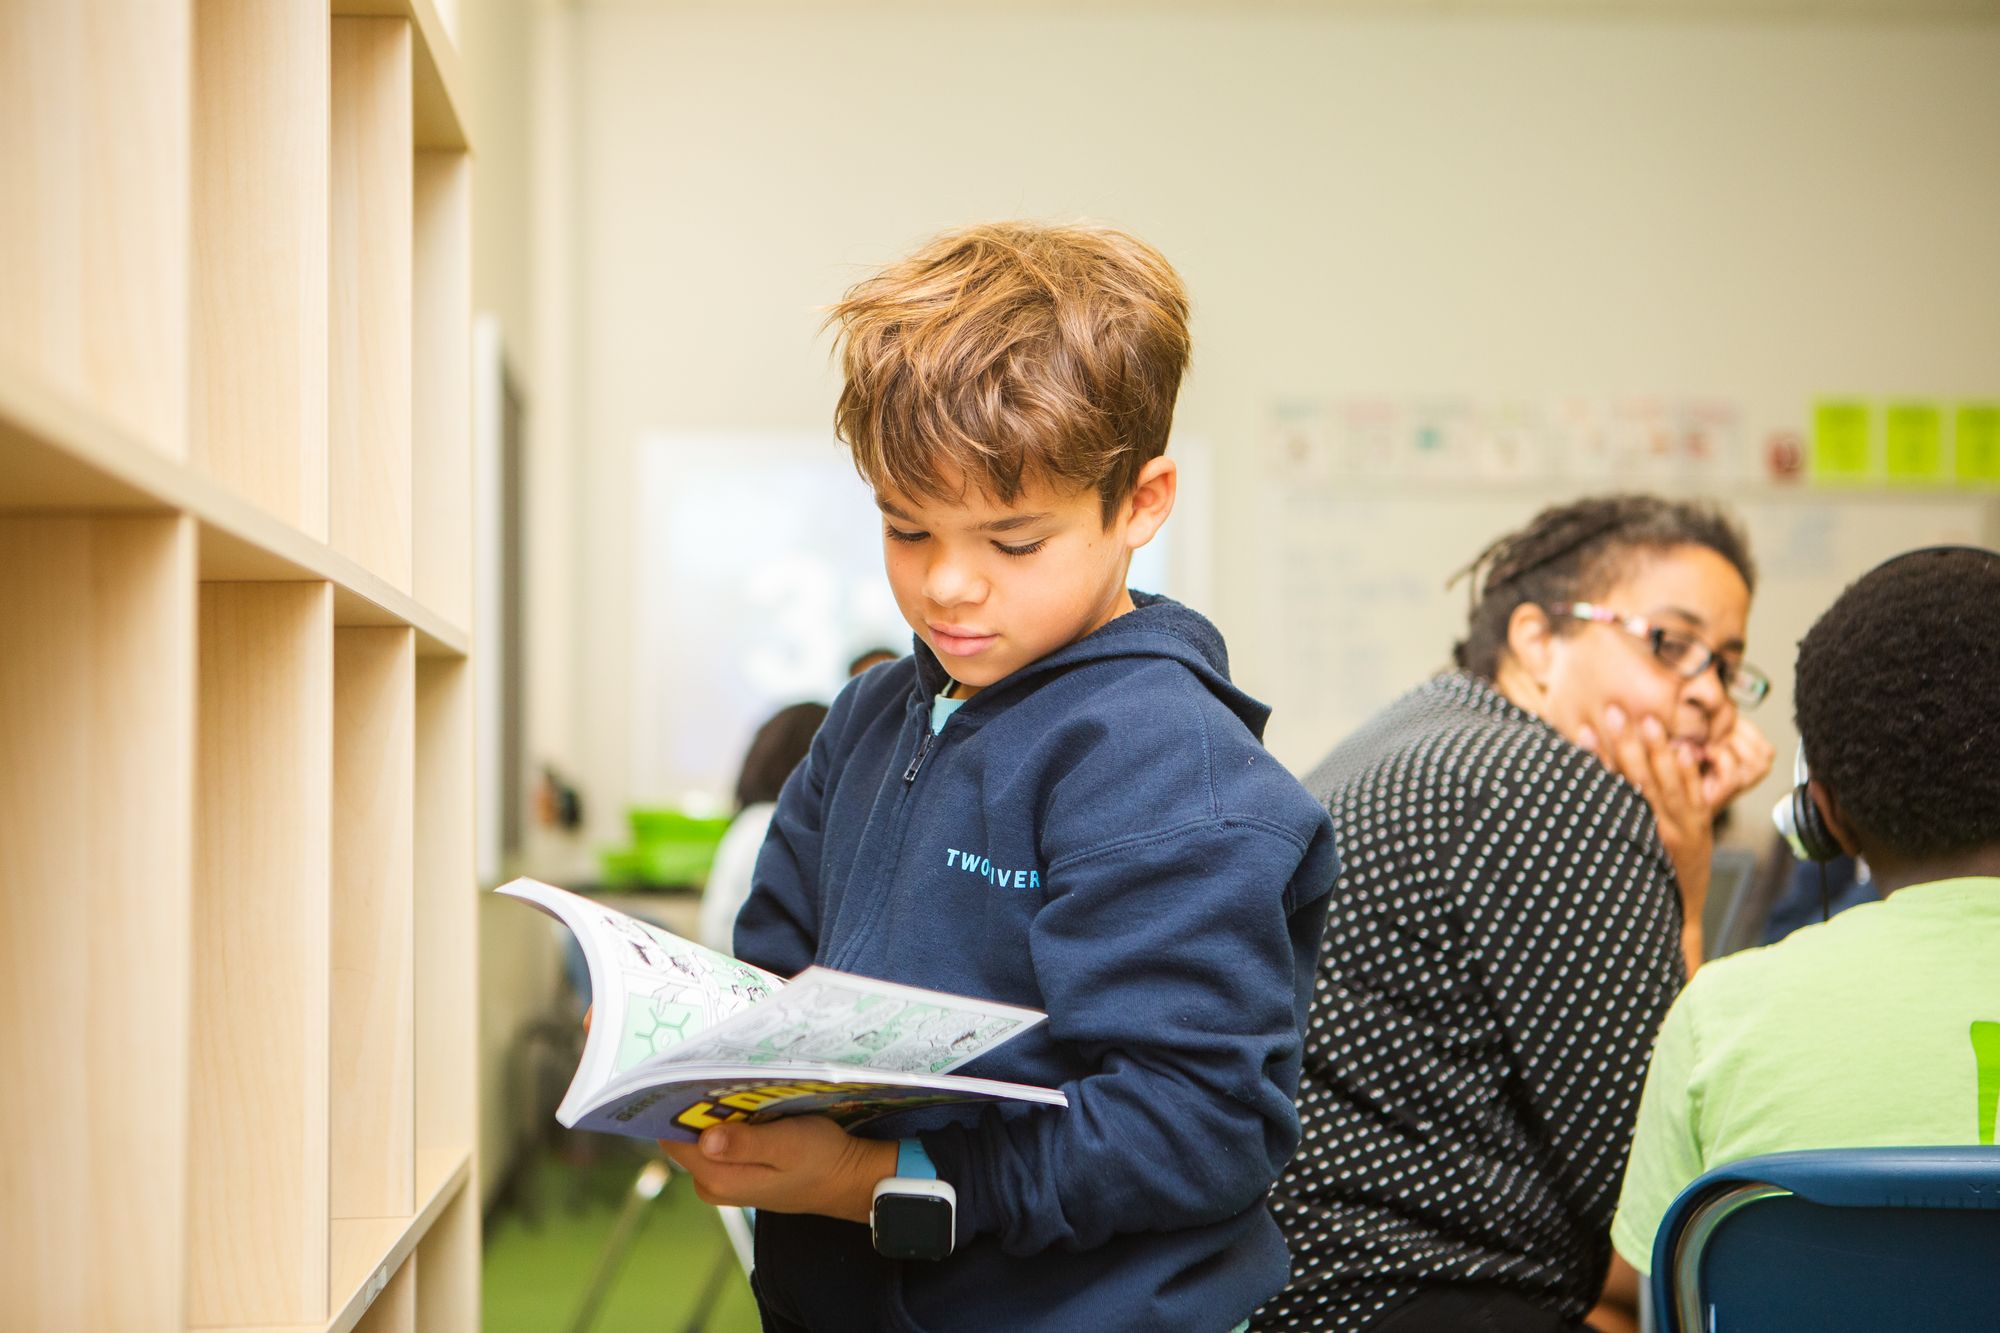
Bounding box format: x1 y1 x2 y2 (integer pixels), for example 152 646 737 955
1612 879 2000 1273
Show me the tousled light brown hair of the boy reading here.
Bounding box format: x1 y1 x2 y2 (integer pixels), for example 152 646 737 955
826 222 1190 522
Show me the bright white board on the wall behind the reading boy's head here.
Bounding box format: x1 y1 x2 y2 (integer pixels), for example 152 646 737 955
628 430 1206 809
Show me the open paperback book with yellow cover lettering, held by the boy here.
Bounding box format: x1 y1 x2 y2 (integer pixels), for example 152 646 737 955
494 879 1070 1141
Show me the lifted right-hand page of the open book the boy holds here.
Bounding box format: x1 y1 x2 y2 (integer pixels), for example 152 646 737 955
662 967 1046 1075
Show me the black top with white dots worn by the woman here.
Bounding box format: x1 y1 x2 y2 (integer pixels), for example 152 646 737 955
1256 675 1684 1329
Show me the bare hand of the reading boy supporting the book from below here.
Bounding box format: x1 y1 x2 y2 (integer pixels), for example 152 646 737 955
660 1115 896 1223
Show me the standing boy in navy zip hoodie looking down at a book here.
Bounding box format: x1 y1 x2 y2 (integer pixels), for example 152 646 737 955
676 224 1336 1333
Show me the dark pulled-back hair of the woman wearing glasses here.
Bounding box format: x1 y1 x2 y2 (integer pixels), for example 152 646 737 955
1446 494 1756 681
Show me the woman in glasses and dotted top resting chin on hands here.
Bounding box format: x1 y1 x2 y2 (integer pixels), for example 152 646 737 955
1256 496 1770 1333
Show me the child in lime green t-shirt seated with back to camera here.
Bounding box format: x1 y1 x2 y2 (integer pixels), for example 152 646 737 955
1612 546 2000 1273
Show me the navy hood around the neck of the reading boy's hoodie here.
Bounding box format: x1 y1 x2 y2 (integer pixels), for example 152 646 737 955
910 590 1270 741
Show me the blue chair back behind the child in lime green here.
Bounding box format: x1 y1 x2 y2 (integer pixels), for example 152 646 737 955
1650 1147 2000 1333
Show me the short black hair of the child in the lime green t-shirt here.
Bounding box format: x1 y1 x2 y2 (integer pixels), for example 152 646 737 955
1794 548 2000 857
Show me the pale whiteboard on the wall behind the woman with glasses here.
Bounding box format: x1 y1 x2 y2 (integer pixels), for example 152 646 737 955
1260 394 2000 809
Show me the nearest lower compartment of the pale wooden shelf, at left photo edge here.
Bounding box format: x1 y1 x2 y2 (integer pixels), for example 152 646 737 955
0 516 196 1333
